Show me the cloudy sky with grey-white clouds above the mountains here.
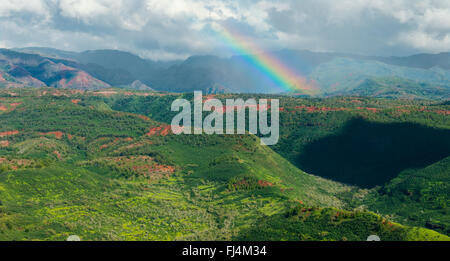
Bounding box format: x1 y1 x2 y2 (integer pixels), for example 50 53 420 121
0 0 450 60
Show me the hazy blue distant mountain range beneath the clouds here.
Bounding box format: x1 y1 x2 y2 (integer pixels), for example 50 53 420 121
0 48 450 99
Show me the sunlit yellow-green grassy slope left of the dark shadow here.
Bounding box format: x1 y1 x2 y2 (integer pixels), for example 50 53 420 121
0 89 448 240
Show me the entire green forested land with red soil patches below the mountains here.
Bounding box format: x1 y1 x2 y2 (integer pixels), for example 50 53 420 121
0 88 450 240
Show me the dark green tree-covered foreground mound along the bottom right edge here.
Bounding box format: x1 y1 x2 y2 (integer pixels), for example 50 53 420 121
236 205 449 241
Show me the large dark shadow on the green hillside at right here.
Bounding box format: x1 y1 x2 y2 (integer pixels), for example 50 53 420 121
297 119 450 188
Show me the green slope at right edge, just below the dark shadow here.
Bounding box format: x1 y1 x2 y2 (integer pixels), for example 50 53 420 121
364 157 450 235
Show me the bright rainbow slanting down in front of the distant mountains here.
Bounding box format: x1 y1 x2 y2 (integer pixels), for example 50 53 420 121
216 26 317 95
